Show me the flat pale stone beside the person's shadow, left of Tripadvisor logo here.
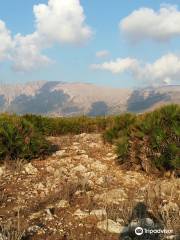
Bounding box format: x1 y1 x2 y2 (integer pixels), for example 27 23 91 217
97 219 125 234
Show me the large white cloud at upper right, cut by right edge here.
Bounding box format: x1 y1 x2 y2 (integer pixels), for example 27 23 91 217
119 5 180 42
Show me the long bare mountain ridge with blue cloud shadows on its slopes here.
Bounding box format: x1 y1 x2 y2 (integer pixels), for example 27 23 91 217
0 81 180 116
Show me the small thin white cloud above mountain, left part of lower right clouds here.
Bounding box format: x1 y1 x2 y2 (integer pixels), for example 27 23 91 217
91 58 137 74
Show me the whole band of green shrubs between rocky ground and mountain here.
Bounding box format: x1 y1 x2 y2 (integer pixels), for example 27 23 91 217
0 105 180 170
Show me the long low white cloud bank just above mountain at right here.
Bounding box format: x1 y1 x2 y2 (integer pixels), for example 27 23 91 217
91 53 180 84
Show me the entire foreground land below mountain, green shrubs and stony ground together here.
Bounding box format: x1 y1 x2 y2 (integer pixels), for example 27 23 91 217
0 105 180 240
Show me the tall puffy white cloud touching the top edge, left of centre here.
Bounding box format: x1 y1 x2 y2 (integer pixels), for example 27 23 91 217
34 0 92 43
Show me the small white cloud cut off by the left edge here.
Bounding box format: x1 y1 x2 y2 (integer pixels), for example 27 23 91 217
0 20 13 61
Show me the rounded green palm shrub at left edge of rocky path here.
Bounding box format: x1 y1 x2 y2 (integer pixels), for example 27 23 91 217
0 114 50 160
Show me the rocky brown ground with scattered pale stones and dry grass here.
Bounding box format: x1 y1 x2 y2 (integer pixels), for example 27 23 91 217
0 134 180 240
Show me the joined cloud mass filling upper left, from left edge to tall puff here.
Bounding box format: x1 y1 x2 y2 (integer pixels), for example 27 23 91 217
0 0 92 71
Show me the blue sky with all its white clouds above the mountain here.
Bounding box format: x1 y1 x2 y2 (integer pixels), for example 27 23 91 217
0 0 180 88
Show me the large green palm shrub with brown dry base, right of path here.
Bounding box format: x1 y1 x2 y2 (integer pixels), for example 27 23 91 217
104 105 180 170
